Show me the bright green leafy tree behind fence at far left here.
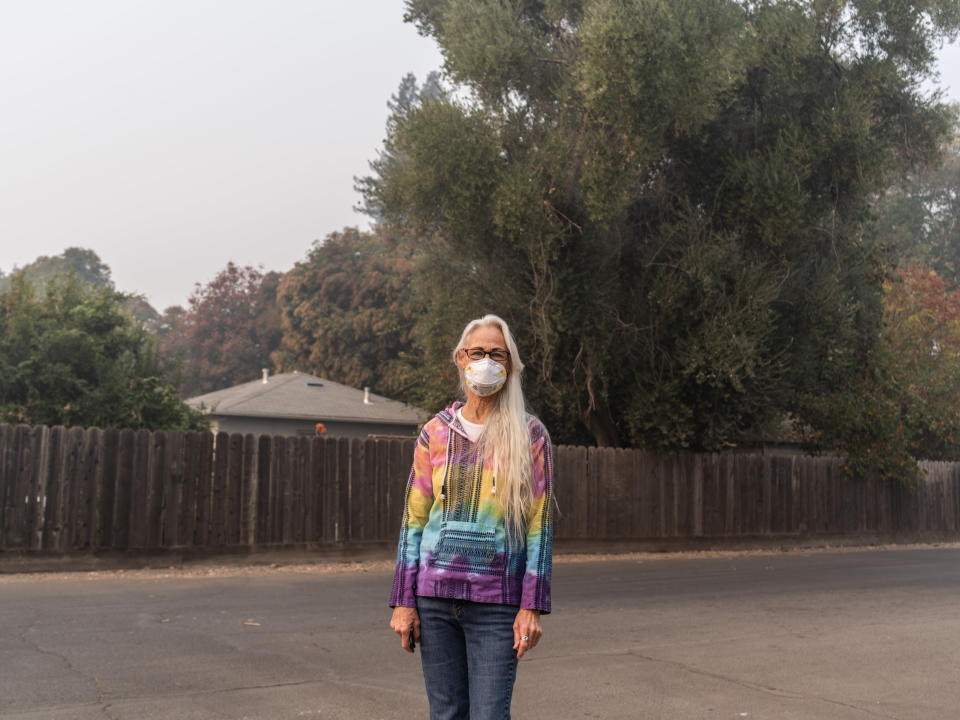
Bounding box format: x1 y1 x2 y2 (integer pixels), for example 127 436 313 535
0 272 202 429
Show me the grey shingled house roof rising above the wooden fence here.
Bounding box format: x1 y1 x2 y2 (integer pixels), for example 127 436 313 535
186 372 428 425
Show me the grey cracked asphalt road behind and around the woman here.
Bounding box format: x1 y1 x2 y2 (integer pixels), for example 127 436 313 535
0 548 960 720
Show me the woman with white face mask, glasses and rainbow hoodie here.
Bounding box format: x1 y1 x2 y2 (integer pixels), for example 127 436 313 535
390 315 553 720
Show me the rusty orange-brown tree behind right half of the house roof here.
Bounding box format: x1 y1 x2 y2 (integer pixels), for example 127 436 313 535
279 228 423 402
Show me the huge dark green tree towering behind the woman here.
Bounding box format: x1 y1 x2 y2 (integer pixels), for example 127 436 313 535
362 0 960 448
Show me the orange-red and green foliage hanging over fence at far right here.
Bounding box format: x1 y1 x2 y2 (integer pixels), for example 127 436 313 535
800 266 960 480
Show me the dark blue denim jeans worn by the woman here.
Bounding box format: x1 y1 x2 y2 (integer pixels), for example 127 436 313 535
417 597 520 720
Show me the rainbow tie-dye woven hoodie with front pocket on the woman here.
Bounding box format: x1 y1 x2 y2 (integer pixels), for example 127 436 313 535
390 403 553 614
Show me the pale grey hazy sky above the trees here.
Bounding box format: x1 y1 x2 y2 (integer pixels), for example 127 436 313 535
0 0 960 310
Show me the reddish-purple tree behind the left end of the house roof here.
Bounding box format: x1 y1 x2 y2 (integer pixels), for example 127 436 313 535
157 262 282 397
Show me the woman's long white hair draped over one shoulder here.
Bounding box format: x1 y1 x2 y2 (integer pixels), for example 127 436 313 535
453 315 533 541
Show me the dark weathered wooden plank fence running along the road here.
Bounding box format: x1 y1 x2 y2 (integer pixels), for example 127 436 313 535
0 425 960 554
